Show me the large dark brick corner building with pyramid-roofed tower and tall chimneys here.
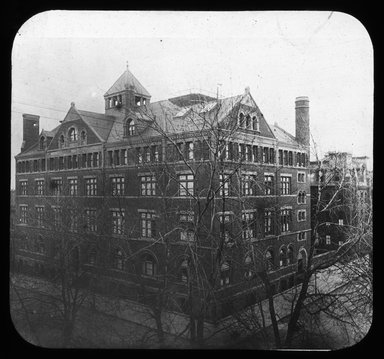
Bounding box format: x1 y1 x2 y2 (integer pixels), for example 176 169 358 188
15 68 310 319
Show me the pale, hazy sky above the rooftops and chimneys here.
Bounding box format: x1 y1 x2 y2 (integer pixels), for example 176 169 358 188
10 11 374 188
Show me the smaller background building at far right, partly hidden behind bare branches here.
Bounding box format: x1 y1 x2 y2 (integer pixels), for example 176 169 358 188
310 152 372 253
